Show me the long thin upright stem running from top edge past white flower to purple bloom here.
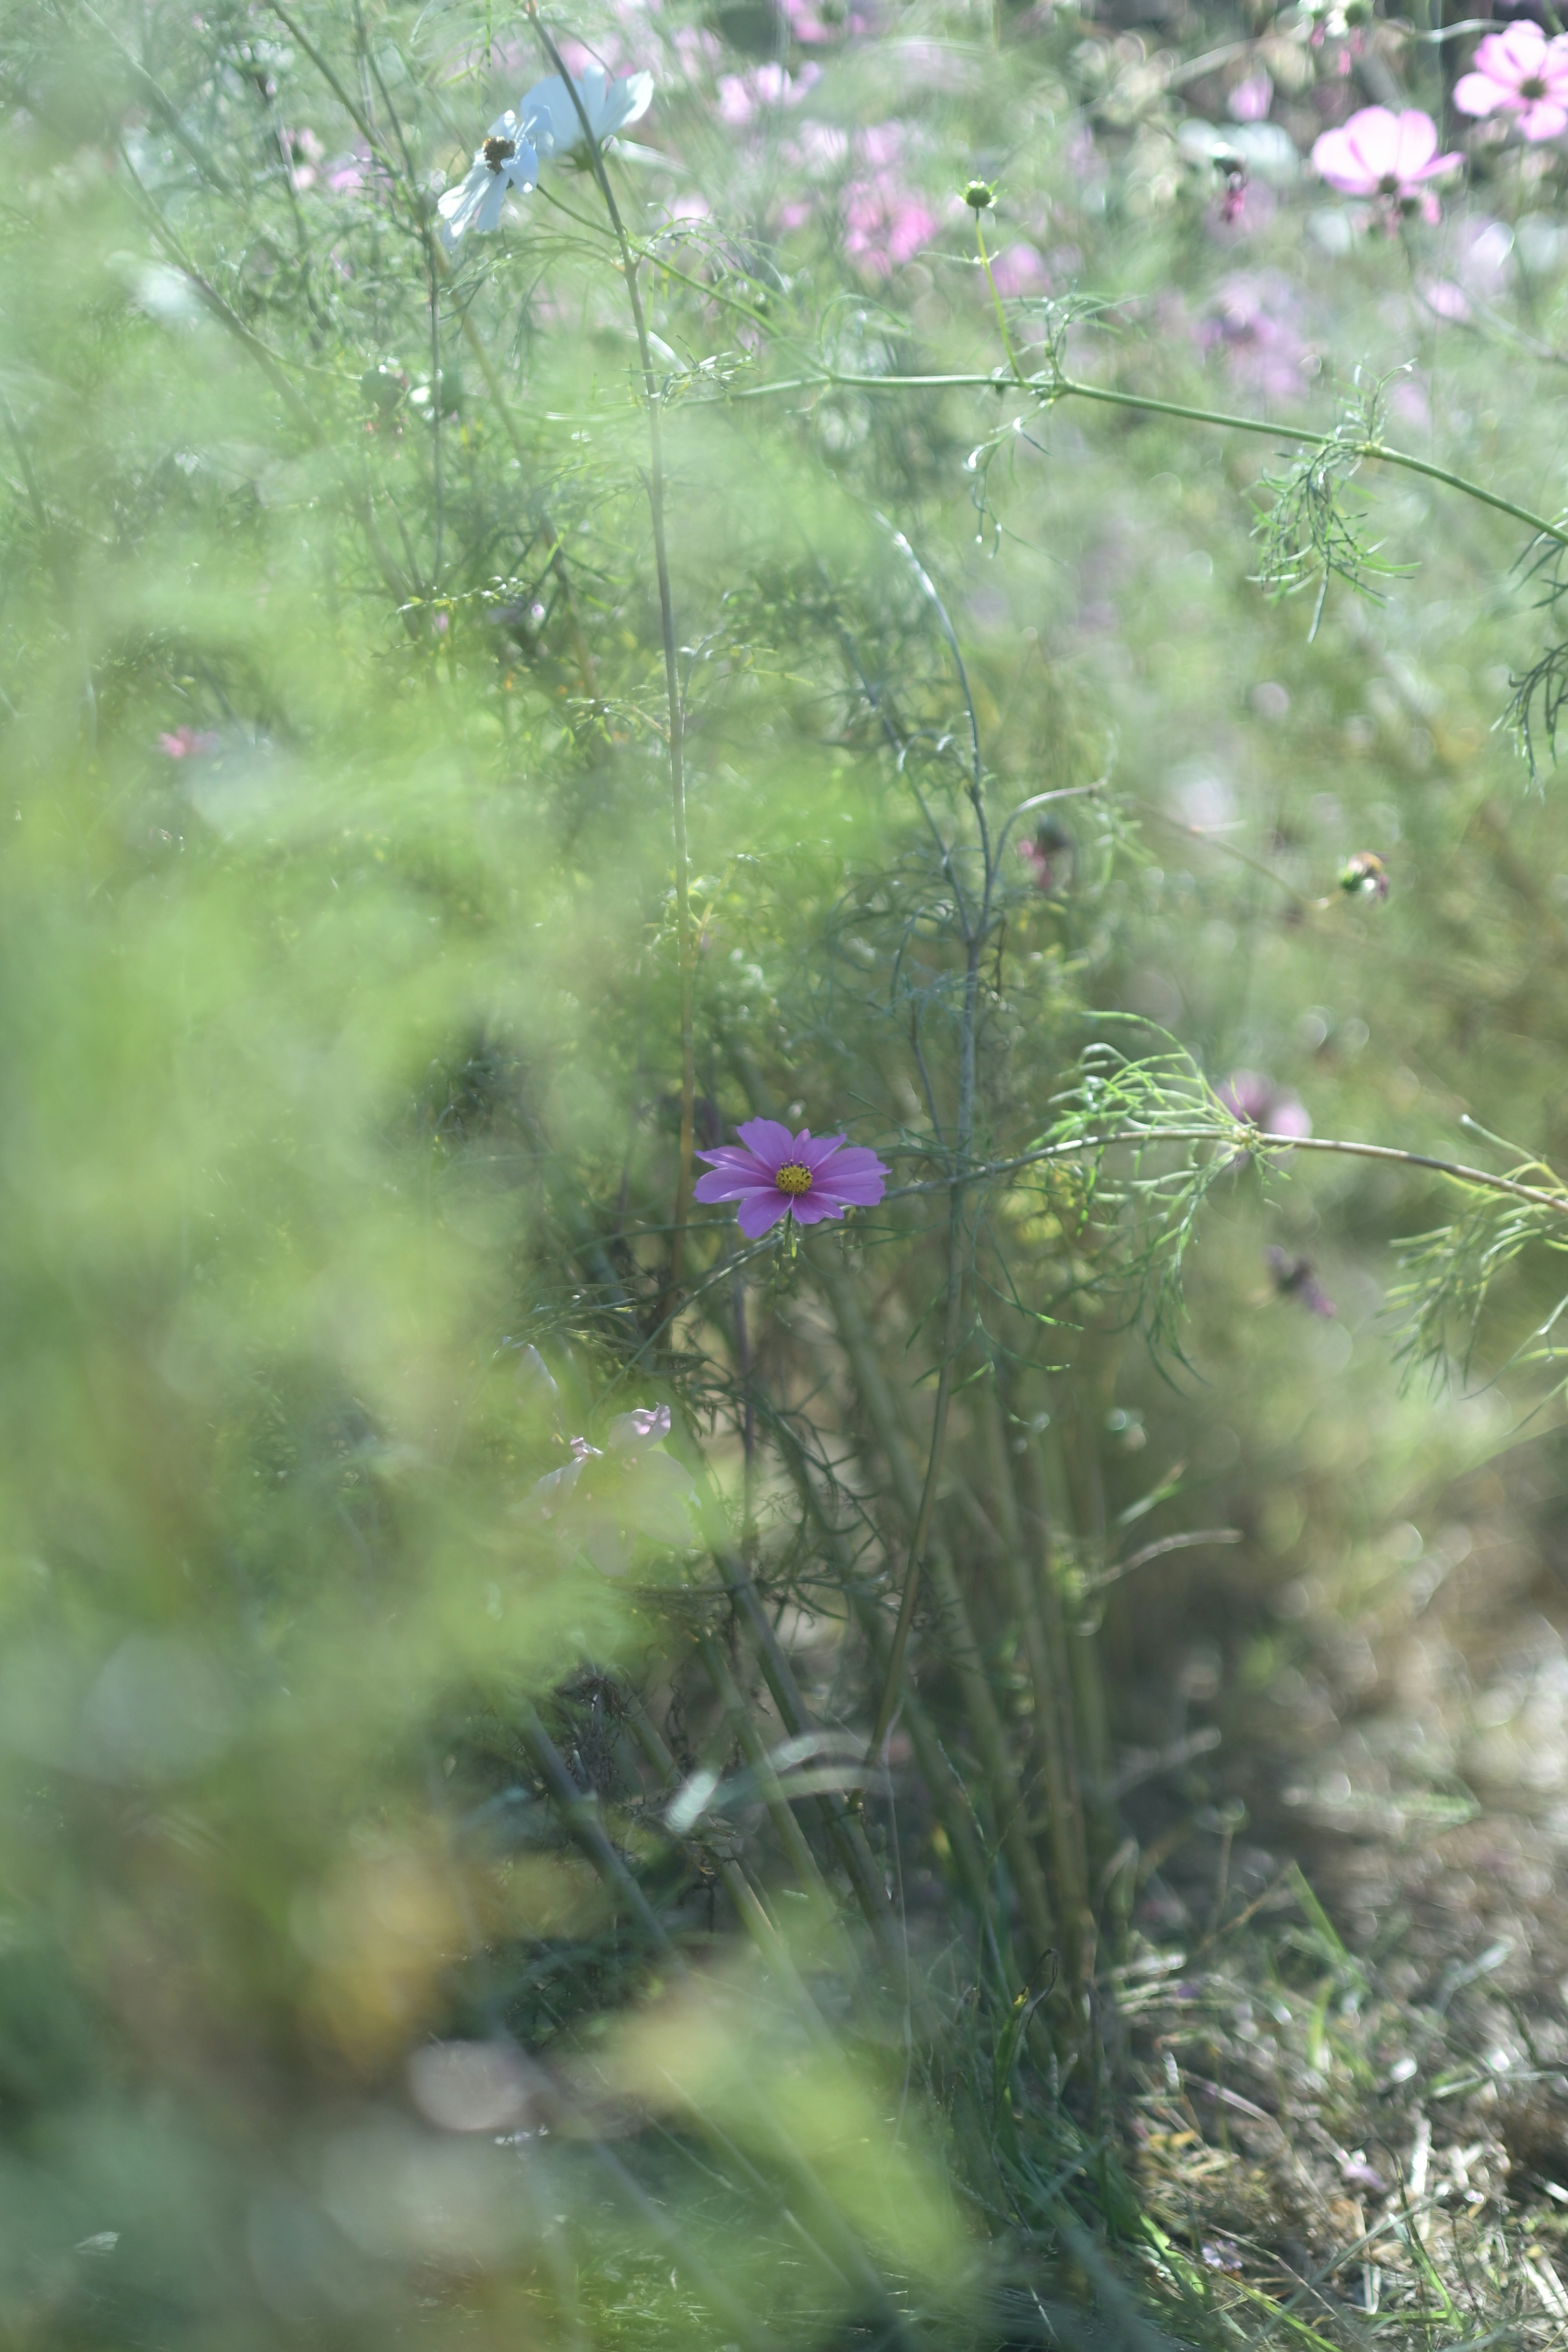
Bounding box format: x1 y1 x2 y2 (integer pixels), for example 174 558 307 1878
529 0 696 1301
